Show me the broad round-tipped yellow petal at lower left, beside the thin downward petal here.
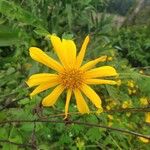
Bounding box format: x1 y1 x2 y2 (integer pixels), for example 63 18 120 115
42 85 64 107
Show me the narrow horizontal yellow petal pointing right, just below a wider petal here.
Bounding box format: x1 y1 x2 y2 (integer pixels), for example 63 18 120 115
85 79 117 85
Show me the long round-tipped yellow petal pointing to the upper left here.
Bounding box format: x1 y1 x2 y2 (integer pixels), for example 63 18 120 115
29 47 63 72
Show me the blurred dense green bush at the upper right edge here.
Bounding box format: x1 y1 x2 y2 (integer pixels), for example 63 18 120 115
112 26 150 67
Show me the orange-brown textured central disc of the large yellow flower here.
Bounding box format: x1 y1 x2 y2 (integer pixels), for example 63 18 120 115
59 69 84 89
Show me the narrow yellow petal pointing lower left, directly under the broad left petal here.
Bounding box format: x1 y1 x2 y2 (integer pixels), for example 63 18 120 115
30 81 59 97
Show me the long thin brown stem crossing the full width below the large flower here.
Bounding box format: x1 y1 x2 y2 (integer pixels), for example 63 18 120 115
0 120 150 140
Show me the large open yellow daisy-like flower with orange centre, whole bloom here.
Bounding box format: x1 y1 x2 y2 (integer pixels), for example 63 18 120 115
26 35 118 118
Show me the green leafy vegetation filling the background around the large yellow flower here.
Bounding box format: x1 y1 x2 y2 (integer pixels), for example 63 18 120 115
0 0 150 150
